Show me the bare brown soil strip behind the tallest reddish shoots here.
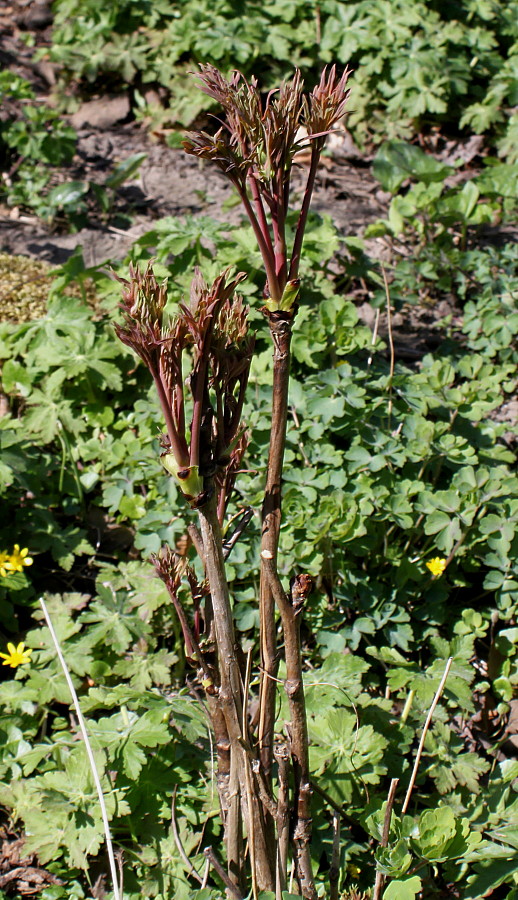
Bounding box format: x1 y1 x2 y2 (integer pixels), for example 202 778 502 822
0 122 386 266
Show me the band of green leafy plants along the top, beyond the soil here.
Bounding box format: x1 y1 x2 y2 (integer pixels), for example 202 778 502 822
44 0 518 156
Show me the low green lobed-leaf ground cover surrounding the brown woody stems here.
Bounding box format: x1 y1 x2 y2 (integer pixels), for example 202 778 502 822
0 3 518 900
